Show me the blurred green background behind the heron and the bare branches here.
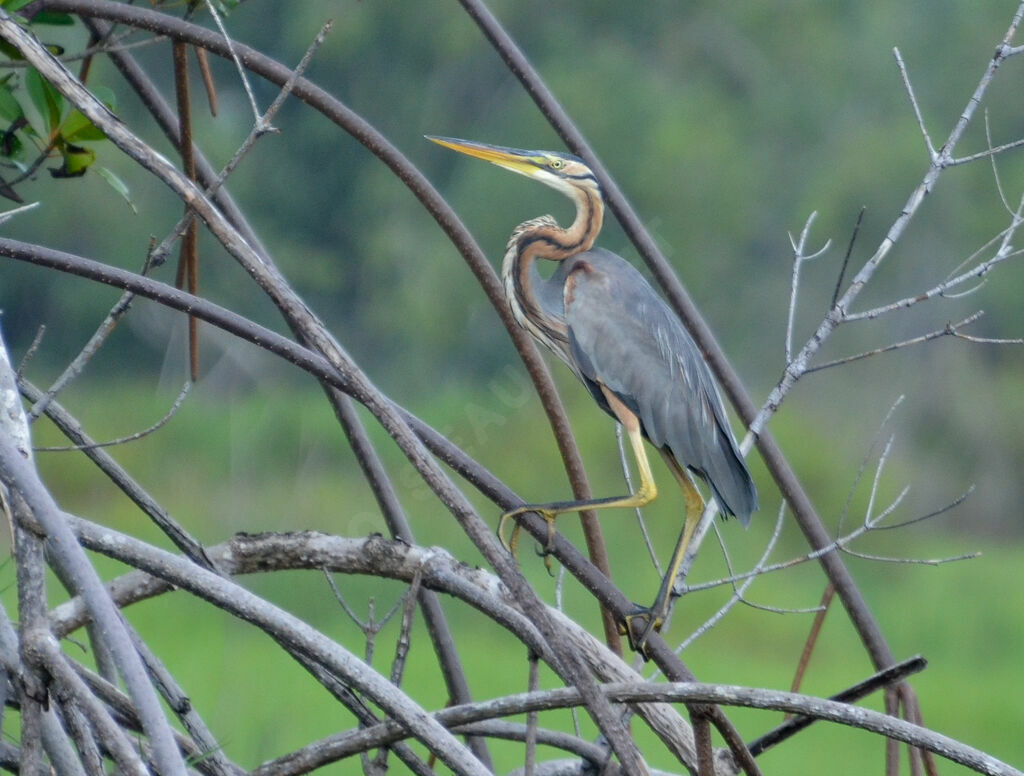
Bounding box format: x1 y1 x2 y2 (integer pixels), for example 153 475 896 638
0 0 1024 773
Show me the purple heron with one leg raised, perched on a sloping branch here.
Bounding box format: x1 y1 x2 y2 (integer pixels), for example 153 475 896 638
427 135 758 651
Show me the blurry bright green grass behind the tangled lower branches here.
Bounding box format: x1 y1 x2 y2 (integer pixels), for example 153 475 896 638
0 384 1024 774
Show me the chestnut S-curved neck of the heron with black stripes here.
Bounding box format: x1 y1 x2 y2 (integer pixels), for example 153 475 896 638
502 187 604 363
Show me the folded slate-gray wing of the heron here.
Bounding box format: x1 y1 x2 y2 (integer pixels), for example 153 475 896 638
560 249 757 525
